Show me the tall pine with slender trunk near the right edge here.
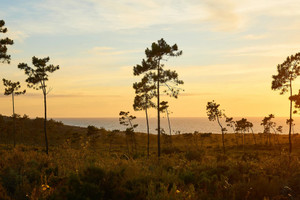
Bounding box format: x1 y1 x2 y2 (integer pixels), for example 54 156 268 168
272 53 300 154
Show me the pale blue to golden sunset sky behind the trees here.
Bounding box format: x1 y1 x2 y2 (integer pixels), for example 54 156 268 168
0 0 300 118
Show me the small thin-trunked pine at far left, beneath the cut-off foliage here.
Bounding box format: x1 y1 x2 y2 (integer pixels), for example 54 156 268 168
2 79 26 147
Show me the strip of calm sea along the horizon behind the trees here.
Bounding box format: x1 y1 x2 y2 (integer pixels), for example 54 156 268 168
54 117 300 134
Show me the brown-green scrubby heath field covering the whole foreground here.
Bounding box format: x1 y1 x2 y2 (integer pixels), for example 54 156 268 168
0 118 300 200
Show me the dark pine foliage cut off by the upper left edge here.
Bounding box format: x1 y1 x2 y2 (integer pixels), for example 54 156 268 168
0 20 14 63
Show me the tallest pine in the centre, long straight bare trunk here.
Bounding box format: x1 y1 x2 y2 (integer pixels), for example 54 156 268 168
133 39 183 157
